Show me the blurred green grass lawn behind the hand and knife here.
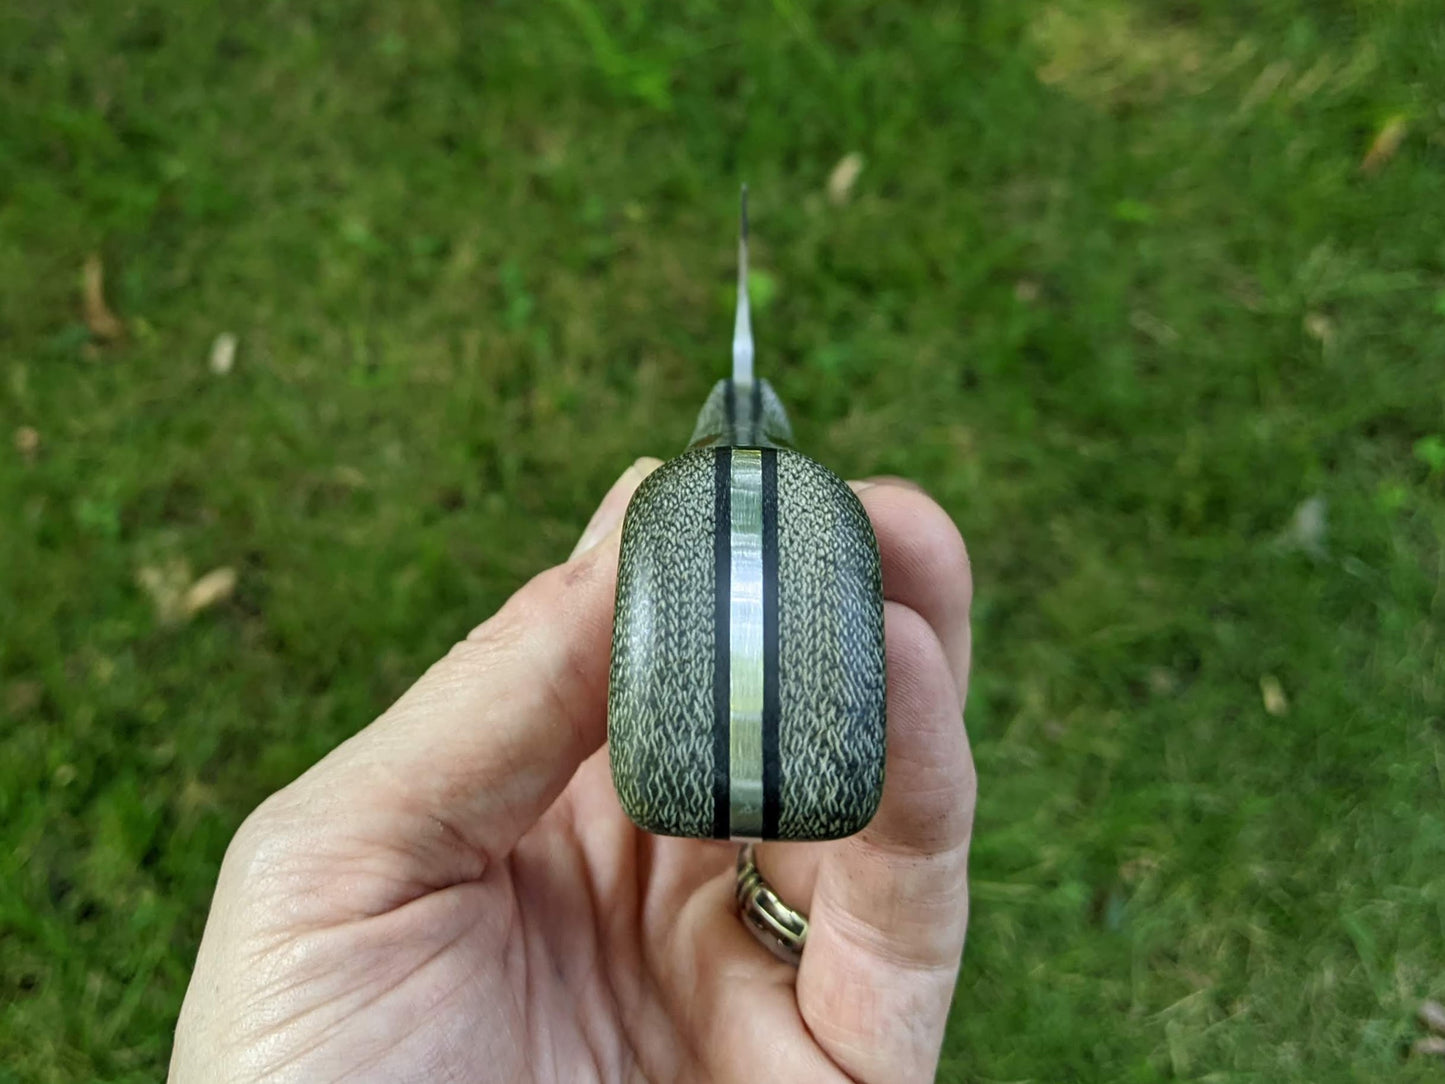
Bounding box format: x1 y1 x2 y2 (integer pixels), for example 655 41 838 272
0 0 1445 1081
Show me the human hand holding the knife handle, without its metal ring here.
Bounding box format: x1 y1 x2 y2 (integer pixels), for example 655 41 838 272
171 460 974 1084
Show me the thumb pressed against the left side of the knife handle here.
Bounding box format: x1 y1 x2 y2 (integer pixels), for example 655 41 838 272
257 458 660 918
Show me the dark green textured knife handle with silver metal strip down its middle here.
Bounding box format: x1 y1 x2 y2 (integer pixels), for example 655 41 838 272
608 380 884 840
